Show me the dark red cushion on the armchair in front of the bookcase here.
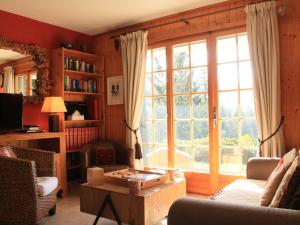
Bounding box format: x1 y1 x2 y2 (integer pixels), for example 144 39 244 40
93 142 115 165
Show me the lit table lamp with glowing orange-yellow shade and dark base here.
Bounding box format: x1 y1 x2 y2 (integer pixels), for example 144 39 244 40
41 97 67 132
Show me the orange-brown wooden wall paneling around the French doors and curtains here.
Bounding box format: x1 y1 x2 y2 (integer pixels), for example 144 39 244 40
95 0 300 194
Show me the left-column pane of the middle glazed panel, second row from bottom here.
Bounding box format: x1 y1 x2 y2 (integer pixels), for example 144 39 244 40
175 121 191 144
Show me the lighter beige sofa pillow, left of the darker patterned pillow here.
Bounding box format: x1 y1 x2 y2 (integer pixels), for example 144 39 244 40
260 149 298 206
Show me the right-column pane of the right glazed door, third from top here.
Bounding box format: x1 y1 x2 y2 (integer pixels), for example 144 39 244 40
240 91 255 117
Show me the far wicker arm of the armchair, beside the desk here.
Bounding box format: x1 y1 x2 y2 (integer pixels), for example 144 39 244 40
13 147 55 177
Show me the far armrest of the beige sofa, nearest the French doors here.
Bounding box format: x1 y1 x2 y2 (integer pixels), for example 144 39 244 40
246 158 280 180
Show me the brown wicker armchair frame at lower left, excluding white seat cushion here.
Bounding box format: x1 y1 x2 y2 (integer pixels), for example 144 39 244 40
0 147 56 225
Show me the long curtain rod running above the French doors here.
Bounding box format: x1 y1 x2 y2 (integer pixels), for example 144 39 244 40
110 0 287 39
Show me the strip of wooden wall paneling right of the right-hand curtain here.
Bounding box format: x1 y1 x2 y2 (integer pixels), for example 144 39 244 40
279 0 300 151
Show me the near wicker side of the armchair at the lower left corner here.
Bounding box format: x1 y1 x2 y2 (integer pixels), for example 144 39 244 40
0 157 38 225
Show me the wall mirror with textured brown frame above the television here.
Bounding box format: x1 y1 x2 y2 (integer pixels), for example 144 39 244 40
0 36 51 103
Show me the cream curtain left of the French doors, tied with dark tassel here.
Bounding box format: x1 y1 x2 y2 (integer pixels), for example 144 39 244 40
120 31 148 168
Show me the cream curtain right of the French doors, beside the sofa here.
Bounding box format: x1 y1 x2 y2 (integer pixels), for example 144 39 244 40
246 1 285 157
